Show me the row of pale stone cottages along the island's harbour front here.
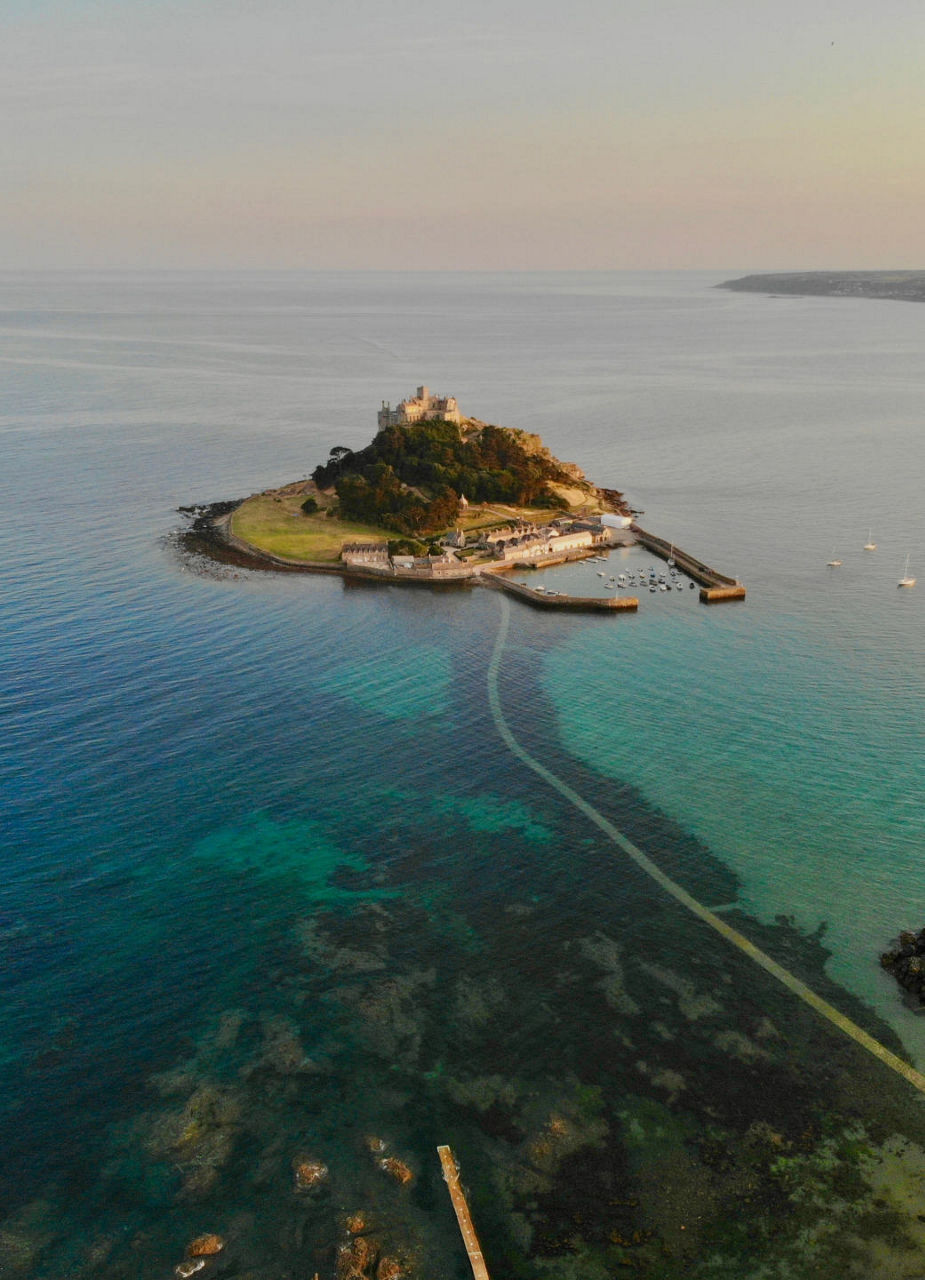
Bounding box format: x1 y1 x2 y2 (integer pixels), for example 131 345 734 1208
340 520 612 572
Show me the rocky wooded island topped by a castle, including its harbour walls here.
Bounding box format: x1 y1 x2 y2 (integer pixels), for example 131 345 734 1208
183 385 745 611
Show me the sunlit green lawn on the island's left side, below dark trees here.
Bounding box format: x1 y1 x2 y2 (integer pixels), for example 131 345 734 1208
232 493 398 561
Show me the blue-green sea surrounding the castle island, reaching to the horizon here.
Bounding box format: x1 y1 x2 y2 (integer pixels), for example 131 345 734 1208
0 270 925 1280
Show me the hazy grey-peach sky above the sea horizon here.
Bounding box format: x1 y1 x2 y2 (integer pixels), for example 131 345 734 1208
7 0 925 269
